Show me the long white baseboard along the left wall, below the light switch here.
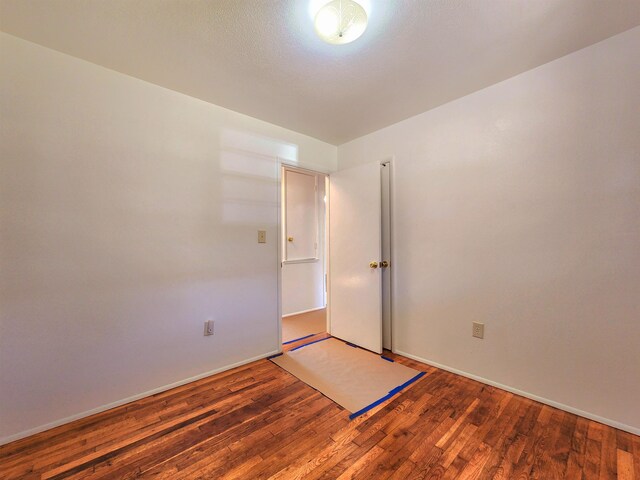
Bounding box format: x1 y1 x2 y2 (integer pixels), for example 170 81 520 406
0 350 280 445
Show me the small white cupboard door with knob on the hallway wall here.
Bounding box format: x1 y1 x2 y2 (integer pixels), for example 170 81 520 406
284 170 318 262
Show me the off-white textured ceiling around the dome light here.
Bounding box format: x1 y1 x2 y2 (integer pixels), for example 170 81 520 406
0 0 640 144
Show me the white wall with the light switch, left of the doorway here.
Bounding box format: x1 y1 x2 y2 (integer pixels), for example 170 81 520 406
0 34 336 442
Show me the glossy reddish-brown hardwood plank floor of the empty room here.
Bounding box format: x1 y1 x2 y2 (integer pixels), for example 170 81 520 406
0 336 640 480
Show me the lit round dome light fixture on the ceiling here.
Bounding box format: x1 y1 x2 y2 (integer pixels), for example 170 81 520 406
314 0 367 45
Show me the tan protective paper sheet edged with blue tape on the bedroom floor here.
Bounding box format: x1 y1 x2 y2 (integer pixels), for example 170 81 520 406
271 338 421 414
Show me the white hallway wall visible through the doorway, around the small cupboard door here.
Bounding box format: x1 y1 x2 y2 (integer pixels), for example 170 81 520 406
282 174 326 315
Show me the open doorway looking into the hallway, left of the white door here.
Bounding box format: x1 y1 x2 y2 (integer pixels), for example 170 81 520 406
281 165 328 348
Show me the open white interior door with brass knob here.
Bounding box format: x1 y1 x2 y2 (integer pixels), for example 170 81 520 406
329 163 382 353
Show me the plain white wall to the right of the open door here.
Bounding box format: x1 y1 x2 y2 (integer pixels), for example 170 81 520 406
338 27 640 433
